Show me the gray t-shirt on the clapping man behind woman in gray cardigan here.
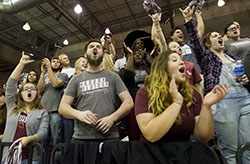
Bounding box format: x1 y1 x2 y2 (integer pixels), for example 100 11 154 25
41 73 68 112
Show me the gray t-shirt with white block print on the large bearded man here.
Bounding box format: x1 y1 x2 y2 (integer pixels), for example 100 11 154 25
65 70 127 139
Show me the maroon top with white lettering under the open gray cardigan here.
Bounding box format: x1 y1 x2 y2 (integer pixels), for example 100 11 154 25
13 112 29 159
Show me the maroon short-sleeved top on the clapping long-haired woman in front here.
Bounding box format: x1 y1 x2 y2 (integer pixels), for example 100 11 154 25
135 87 202 142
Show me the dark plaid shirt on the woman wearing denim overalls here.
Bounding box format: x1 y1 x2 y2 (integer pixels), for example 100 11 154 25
185 19 239 95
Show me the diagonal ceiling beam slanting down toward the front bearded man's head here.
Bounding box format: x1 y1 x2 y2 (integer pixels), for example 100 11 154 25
48 1 94 39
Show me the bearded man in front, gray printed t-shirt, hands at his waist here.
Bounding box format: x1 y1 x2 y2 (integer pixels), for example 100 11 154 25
59 40 133 143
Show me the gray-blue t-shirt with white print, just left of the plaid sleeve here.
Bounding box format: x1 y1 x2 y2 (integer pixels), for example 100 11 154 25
181 43 201 73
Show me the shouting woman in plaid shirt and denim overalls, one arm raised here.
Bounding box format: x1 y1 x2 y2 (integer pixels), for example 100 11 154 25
180 7 250 164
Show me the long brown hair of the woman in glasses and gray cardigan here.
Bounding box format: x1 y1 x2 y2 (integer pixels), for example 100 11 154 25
11 83 44 114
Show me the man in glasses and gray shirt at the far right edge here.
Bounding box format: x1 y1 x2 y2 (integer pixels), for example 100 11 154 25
224 22 250 78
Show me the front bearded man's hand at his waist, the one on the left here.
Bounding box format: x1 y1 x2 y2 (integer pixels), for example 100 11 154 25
77 110 97 125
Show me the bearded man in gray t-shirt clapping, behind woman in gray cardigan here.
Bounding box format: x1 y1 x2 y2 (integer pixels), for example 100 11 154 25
37 58 68 144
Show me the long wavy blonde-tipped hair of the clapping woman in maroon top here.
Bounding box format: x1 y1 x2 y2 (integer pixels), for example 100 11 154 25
144 51 194 125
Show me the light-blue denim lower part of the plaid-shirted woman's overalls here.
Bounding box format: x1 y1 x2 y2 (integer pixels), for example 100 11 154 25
213 88 250 164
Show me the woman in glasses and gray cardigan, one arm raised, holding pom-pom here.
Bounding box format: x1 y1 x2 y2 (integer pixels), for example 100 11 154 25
2 52 49 164
